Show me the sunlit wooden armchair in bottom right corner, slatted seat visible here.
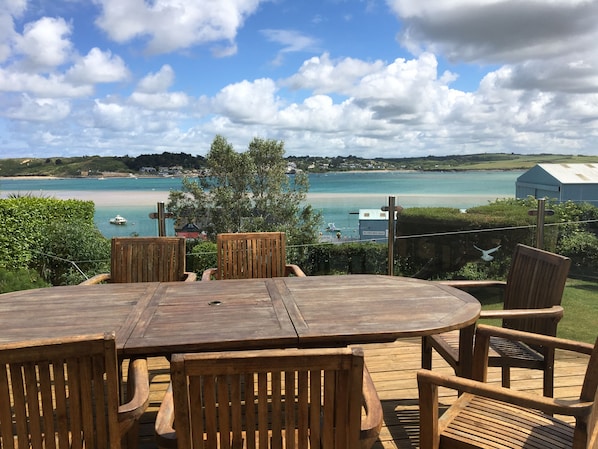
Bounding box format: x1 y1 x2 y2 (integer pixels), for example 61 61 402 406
417 325 598 449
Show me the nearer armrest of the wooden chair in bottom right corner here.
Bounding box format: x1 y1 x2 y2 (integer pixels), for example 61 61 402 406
417 370 593 418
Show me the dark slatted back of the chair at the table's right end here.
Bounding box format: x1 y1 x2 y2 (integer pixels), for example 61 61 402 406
503 244 571 337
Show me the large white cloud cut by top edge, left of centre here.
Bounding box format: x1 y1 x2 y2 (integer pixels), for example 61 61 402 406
96 0 262 53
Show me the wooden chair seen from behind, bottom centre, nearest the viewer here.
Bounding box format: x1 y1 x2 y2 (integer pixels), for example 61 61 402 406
156 348 382 449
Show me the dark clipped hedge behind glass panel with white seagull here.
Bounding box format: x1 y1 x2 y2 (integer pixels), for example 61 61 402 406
395 198 571 279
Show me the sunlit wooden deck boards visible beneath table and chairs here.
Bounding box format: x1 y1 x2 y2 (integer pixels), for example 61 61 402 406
135 339 588 449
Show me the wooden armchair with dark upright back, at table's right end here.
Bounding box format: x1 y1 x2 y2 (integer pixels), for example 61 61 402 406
422 244 571 396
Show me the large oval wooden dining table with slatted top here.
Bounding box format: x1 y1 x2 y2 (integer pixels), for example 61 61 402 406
0 274 481 374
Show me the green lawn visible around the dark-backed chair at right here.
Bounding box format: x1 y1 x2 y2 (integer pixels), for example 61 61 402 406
470 279 598 343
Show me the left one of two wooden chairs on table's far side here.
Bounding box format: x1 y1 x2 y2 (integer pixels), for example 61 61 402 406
81 237 197 285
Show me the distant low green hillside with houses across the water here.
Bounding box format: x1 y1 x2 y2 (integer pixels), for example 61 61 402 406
0 153 598 177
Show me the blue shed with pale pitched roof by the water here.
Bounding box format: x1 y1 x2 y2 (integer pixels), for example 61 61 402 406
515 164 598 206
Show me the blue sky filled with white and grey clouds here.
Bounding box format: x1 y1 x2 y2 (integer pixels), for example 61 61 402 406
0 0 598 158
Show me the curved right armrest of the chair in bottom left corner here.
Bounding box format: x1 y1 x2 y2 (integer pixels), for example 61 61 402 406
118 359 149 432
